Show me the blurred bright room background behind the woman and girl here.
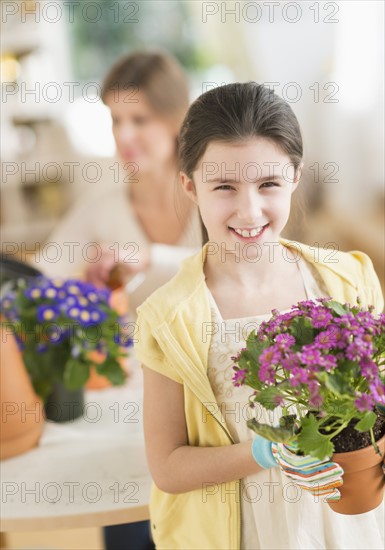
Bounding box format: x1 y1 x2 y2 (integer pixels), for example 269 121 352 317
0 0 385 548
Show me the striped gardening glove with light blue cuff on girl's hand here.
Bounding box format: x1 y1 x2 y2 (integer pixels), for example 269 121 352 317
252 435 344 502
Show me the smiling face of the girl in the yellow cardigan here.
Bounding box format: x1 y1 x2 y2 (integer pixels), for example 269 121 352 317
181 137 299 254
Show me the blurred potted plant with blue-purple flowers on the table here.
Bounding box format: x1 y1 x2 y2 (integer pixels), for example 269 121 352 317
1 276 131 421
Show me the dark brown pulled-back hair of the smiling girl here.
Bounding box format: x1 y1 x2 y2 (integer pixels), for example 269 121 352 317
179 82 303 241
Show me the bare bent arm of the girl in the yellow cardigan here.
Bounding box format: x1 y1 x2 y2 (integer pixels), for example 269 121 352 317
143 365 262 493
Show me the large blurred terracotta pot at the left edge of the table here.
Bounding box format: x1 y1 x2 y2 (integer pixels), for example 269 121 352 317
0 325 45 460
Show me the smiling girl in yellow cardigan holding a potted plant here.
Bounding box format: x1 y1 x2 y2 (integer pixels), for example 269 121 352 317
136 82 384 550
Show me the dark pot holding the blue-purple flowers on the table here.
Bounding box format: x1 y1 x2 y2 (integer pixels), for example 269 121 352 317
44 382 84 422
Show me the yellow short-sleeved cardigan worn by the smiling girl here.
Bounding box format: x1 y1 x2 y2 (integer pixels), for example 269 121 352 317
135 239 384 550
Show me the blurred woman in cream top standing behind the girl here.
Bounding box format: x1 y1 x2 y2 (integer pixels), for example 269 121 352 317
44 52 201 311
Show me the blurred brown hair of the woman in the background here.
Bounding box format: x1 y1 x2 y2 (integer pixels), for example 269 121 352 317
101 52 189 131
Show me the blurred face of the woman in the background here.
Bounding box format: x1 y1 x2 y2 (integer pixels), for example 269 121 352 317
106 90 176 172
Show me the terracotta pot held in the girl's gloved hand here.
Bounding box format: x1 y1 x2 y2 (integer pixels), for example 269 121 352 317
329 435 385 515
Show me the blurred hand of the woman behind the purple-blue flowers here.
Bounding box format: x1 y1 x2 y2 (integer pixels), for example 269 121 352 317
85 248 150 290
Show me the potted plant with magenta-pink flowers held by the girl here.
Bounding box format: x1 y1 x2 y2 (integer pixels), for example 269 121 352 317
233 298 385 514
